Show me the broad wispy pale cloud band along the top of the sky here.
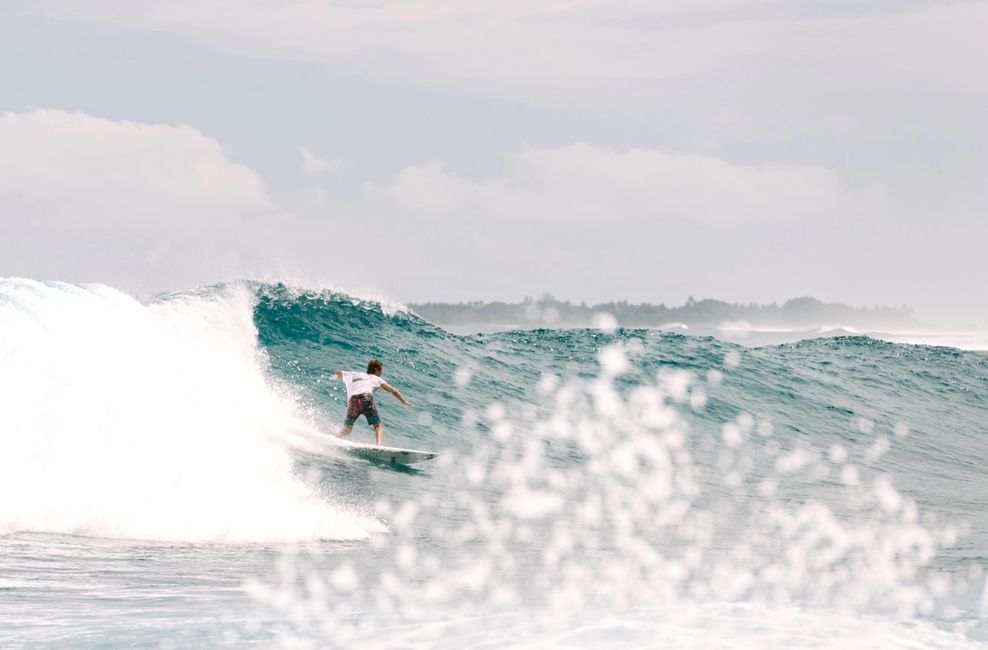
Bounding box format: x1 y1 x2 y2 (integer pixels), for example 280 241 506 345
29 0 988 93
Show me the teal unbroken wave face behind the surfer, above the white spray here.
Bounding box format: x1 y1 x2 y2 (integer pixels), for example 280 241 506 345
255 286 988 532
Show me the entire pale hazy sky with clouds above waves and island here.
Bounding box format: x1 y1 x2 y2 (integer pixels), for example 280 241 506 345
0 0 988 327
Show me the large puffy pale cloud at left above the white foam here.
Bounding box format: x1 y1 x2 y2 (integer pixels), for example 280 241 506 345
0 110 276 292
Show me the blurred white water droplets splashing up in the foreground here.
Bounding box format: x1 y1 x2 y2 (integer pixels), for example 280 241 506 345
249 342 980 648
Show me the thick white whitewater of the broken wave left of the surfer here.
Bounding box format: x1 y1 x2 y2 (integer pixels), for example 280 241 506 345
0 280 382 541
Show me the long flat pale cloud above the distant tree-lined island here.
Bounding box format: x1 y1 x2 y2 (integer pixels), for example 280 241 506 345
370 143 881 224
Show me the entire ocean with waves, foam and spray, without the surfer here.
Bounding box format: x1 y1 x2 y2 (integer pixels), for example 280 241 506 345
0 279 988 648
